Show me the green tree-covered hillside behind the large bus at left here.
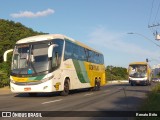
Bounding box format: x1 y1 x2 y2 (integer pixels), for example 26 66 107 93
0 19 44 87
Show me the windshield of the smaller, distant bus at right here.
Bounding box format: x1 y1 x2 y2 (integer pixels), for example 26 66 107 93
129 65 147 78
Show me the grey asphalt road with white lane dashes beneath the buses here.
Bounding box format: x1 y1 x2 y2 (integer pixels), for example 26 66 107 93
0 83 158 120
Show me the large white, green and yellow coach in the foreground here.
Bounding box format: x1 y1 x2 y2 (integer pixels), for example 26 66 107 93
7 34 106 95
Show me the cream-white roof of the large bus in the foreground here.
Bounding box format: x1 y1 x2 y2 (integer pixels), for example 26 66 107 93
16 34 101 53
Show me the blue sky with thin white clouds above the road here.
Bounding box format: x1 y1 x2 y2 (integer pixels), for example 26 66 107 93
0 0 160 68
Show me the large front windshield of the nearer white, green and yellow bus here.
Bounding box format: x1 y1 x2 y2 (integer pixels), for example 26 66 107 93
11 43 49 75
